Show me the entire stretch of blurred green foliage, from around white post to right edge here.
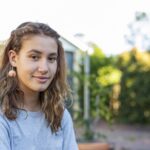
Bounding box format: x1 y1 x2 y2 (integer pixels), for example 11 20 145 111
73 42 150 131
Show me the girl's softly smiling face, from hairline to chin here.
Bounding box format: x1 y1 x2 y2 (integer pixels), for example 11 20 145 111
10 35 58 92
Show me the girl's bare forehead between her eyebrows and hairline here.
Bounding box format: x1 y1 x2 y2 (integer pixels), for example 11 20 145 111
21 35 58 53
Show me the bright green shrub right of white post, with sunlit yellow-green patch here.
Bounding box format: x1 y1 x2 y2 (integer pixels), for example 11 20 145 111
89 45 121 122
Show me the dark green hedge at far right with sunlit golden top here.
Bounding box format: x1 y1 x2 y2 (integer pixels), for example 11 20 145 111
118 49 150 123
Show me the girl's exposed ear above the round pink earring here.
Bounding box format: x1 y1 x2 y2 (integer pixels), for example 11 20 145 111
8 50 17 67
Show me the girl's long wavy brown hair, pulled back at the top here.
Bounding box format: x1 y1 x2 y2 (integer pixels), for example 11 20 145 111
0 22 70 132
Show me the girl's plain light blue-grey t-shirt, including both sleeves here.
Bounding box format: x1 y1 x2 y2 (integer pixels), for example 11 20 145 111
0 109 78 150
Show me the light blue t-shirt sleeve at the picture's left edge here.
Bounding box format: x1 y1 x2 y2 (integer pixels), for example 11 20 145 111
0 114 11 150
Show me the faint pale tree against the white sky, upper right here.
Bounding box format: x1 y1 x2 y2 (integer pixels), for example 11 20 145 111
125 12 150 50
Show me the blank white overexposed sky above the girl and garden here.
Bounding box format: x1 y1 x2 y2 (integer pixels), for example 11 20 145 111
0 0 150 54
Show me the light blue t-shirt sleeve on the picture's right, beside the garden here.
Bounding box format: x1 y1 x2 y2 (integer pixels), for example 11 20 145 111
62 109 78 150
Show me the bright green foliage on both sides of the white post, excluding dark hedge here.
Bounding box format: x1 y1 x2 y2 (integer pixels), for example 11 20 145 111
73 44 121 122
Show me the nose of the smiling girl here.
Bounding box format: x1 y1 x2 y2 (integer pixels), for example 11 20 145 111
38 60 48 74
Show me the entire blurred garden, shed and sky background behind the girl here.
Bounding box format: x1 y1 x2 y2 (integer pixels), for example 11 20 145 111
0 0 150 150
